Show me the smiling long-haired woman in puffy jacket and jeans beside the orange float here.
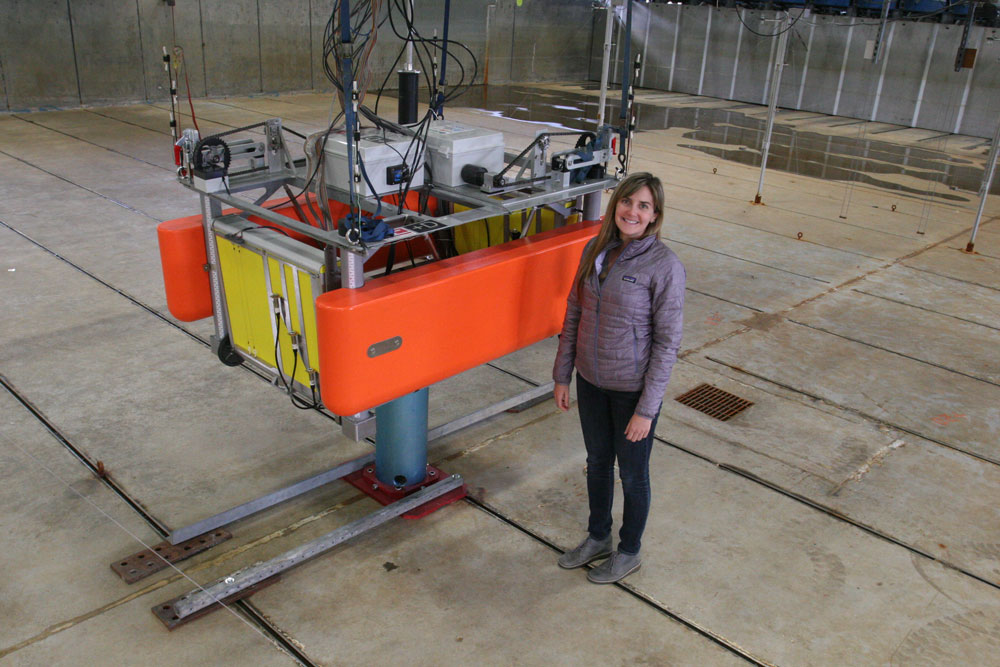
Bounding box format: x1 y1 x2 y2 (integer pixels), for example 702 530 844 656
552 173 685 584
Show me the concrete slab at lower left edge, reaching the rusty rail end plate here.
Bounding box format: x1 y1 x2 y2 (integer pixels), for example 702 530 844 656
0 388 160 657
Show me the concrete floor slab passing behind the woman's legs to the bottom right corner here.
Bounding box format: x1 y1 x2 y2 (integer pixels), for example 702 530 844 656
453 409 1000 664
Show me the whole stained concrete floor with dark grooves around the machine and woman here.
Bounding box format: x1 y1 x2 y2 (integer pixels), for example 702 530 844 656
0 85 1000 665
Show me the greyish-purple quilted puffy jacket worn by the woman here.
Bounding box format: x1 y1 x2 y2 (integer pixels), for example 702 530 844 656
552 236 686 419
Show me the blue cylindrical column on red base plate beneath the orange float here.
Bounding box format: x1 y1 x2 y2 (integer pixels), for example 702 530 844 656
375 387 428 488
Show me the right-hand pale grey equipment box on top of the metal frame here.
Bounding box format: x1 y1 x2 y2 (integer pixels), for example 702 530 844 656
427 120 504 187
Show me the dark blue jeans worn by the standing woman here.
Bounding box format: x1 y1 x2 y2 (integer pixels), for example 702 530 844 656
576 373 656 554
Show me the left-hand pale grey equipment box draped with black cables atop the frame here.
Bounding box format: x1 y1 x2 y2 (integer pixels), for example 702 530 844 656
324 127 424 197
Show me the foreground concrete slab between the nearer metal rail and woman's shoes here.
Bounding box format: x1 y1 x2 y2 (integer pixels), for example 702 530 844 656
244 503 742 665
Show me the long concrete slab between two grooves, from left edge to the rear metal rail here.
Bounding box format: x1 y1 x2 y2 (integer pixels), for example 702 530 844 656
0 233 367 528
